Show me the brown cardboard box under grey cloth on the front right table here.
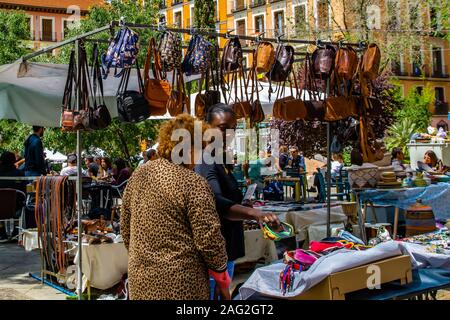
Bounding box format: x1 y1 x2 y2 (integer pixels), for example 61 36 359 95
292 255 412 300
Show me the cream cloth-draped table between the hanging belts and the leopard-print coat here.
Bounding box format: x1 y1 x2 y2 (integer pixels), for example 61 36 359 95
75 242 128 290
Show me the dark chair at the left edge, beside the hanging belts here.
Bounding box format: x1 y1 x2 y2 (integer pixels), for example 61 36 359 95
0 188 26 238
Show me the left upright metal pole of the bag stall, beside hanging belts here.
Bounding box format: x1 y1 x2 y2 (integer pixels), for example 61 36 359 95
75 40 83 300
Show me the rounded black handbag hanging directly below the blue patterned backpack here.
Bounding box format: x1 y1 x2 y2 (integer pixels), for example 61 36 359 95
117 61 150 123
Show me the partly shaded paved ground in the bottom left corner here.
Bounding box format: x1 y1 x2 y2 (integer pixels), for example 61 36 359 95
0 243 66 300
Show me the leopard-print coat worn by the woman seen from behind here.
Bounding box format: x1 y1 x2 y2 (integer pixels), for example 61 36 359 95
120 159 227 300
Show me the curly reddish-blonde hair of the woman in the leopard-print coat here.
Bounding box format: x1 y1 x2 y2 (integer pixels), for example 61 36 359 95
158 114 210 165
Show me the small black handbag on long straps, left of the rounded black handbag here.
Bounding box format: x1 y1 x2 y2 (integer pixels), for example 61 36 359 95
92 43 111 129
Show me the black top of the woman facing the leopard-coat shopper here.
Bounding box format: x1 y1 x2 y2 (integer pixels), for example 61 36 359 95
195 163 245 261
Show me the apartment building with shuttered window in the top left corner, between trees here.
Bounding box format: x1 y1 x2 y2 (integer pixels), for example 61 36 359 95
0 0 104 49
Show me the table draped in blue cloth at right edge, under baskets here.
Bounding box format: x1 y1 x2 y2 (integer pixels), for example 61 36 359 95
354 183 450 240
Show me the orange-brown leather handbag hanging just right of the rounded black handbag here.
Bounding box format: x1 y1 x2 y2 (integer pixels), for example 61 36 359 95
144 38 171 115
